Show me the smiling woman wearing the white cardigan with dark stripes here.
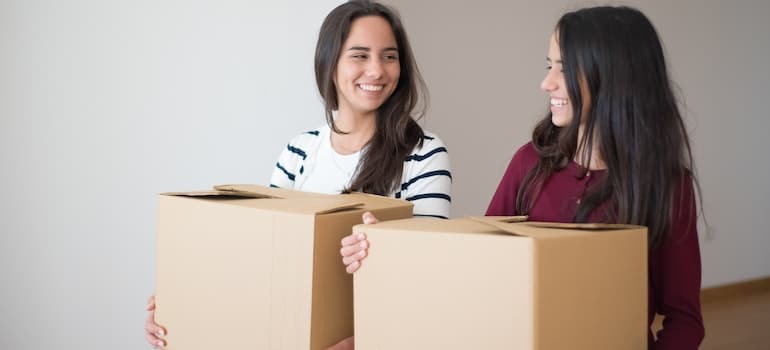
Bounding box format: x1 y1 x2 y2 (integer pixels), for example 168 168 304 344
145 0 452 350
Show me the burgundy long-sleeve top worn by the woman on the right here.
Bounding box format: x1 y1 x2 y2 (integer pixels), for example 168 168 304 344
486 143 704 350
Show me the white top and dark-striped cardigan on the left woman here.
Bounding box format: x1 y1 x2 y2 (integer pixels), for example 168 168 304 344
270 125 452 218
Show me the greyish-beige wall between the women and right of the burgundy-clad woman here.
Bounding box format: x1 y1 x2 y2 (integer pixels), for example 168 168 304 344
389 0 770 287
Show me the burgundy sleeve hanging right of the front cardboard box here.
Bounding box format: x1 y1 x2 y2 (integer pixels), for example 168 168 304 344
650 177 705 350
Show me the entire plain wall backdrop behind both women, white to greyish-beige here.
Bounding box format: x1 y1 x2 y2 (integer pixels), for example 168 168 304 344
0 0 770 349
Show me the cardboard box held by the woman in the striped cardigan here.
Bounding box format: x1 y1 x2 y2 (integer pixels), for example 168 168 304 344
155 185 412 350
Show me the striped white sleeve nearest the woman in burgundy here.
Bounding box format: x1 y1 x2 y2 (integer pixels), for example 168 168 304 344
395 136 452 219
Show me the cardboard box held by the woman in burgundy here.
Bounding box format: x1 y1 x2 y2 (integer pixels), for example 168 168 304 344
354 218 647 350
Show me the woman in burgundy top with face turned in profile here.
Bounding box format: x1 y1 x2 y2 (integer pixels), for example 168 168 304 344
487 7 704 350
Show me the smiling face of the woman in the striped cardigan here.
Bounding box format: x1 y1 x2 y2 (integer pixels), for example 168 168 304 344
334 16 401 119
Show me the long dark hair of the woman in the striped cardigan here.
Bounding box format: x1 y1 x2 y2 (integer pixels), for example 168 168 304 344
315 0 428 195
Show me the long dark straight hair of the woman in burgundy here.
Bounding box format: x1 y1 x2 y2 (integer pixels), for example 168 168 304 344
516 7 697 247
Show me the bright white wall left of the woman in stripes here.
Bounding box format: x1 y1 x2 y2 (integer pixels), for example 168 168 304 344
0 0 341 349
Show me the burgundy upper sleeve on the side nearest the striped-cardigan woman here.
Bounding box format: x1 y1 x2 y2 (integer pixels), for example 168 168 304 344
486 143 537 216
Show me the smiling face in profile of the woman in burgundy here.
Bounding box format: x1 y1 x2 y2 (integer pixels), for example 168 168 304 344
540 33 574 127
